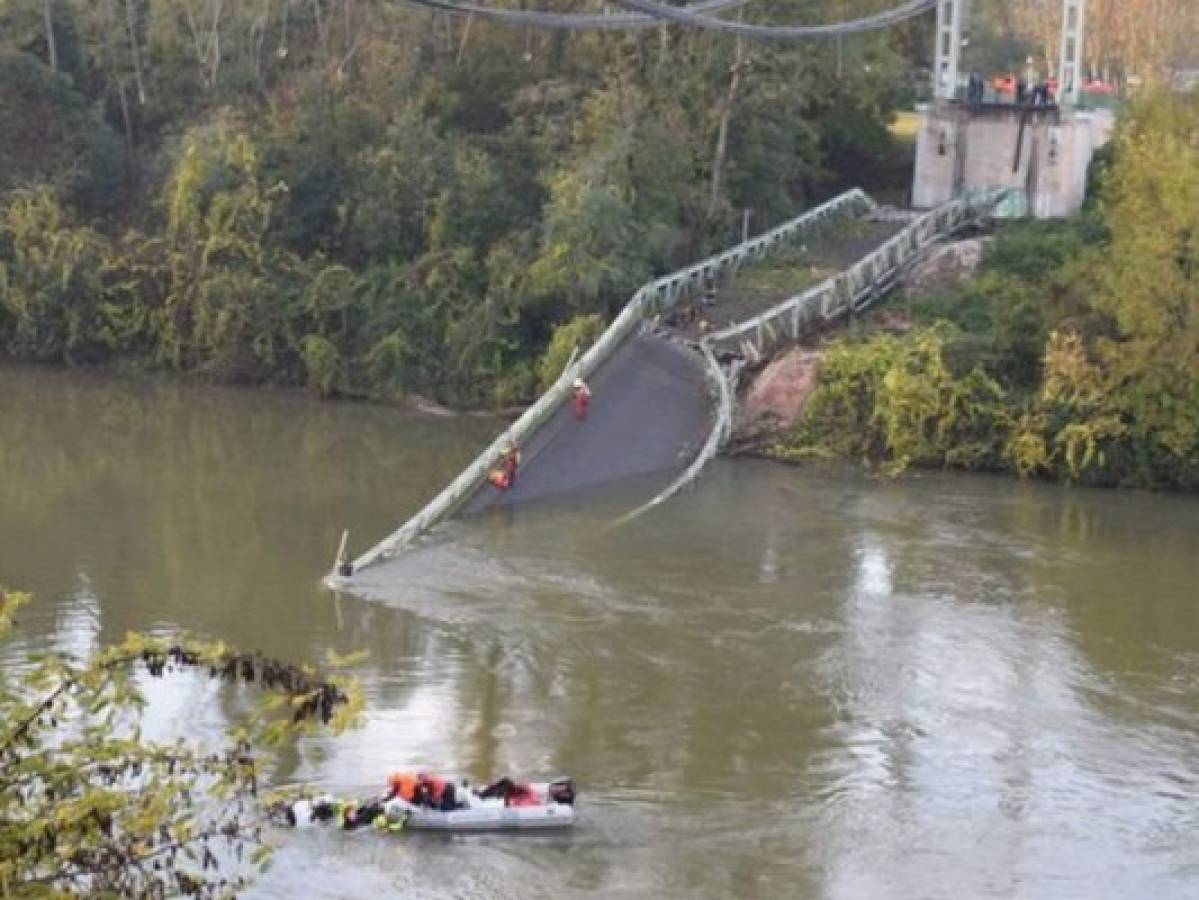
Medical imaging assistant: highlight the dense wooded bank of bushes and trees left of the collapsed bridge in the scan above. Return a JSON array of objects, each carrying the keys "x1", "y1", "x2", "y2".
[{"x1": 0, "y1": 0, "x2": 902, "y2": 404}]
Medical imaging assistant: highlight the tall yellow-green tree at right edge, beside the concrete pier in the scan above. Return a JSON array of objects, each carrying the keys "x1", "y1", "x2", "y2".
[{"x1": 1078, "y1": 92, "x2": 1199, "y2": 484}]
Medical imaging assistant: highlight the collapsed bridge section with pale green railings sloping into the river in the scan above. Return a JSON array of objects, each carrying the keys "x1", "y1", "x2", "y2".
[{"x1": 329, "y1": 188, "x2": 1002, "y2": 586}]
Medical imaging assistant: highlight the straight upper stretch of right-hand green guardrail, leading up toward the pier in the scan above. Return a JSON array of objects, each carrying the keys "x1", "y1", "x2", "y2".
[{"x1": 704, "y1": 188, "x2": 1011, "y2": 357}]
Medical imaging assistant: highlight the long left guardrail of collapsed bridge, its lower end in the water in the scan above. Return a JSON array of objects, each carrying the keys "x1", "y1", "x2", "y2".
[{"x1": 342, "y1": 188, "x2": 876, "y2": 577}]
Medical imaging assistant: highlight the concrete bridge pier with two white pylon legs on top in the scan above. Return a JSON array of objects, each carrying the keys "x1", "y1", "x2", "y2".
[{"x1": 911, "y1": 0, "x2": 1111, "y2": 218}]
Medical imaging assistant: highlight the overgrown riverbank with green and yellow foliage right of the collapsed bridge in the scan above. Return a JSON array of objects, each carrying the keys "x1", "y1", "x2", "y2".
[{"x1": 738, "y1": 93, "x2": 1199, "y2": 491}]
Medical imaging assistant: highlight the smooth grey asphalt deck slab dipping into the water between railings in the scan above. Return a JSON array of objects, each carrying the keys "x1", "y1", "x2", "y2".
[{"x1": 466, "y1": 334, "x2": 712, "y2": 512}]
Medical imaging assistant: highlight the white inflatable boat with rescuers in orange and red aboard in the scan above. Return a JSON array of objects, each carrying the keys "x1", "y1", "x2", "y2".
[{"x1": 285, "y1": 779, "x2": 576, "y2": 832}]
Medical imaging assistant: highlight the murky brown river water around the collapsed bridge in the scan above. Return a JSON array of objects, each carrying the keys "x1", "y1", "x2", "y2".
[{"x1": 0, "y1": 361, "x2": 1199, "y2": 898}]
